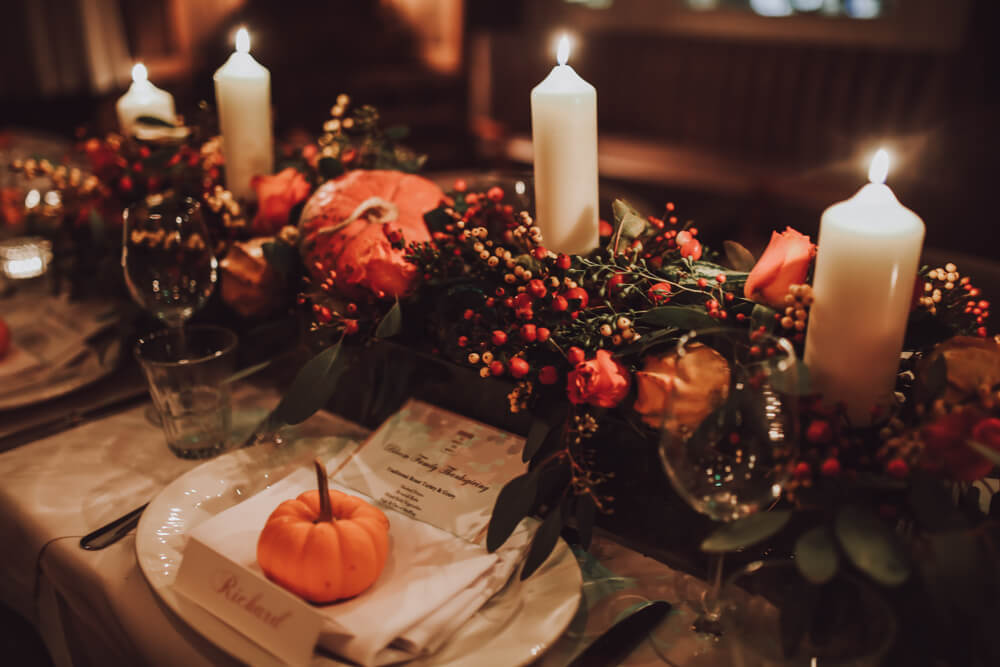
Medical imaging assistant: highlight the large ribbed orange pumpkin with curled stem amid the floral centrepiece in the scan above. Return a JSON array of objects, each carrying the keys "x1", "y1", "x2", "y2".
[{"x1": 299, "y1": 169, "x2": 444, "y2": 298}]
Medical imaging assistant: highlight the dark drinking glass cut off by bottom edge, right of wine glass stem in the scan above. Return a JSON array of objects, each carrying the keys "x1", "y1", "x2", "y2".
[{"x1": 722, "y1": 560, "x2": 896, "y2": 667}]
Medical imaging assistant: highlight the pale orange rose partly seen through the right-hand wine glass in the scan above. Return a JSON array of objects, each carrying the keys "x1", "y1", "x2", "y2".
[{"x1": 632, "y1": 343, "x2": 729, "y2": 433}]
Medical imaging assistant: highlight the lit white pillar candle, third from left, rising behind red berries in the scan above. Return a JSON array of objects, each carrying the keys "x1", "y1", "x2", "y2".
[{"x1": 531, "y1": 36, "x2": 598, "y2": 254}]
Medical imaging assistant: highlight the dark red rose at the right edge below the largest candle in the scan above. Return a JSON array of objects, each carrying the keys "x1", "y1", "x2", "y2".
[{"x1": 920, "y1": 409, "x2": 1000, "y2": 482}]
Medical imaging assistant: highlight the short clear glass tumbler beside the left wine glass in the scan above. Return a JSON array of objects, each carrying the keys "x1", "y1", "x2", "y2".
[{"x1": 135, "y1": 326, "x2": 237, "y2": 459}]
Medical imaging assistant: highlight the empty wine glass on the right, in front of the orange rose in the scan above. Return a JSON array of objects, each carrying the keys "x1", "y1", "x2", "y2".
[{"x1": 659, "y1": 328, "x2": 799, "y2": 656}]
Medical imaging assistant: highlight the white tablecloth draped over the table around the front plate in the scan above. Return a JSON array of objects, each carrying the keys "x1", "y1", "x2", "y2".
[{"x1": 0, "y1": 387, "x2": 720, "y2": 667}]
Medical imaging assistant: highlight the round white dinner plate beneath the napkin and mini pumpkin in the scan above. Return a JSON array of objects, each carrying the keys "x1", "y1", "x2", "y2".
[{"x1": 135, "y1": 418, "x2": 582, "y2": 667}]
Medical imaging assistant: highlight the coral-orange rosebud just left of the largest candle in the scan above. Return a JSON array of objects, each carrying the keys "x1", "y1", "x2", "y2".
[{"x1": 743, "y1": 227, "x2": 816, "y2": 307}]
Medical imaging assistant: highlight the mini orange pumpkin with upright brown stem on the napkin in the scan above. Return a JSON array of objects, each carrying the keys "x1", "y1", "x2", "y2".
[{"x1": 257, "y1": 460, "x2": 389, "y2": 603}]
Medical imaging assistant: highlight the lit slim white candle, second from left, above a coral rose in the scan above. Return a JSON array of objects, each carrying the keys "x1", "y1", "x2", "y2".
[{"x1": 215, "y1": 28, "x2": 274, "y2": 199}]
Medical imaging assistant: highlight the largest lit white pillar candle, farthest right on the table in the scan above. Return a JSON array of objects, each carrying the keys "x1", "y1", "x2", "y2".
[{"x1": 805, "y1": 150, "x2": 924, "y2": 425}]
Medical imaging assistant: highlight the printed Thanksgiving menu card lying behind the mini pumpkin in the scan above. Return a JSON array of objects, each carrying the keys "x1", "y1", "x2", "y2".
[{"x1": 333, "y1": 400, "x2": 526, "y2": 541}]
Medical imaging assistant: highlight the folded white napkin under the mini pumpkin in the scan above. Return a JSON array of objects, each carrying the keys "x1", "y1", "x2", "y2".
[{"x1": 192, "y1": 460, "x2": 533, "y2": 665}]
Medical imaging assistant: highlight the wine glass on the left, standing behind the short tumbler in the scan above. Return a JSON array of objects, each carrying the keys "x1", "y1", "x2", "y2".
[{"x1": 122, "y1": 195, "x2": 218, "y2": 346}]
